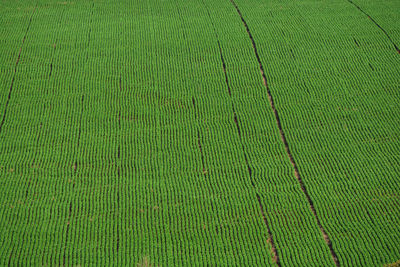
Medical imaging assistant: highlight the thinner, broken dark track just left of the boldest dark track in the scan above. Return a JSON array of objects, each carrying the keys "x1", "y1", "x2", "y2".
[{"x1": 202, "y1": 0, "x2": 281, "y2": 266}]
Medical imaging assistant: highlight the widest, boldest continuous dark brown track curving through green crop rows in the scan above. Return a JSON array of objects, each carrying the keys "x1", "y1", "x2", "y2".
[{"x1": 229, "y1": 0, "x2": 340, "y2": 266}]
